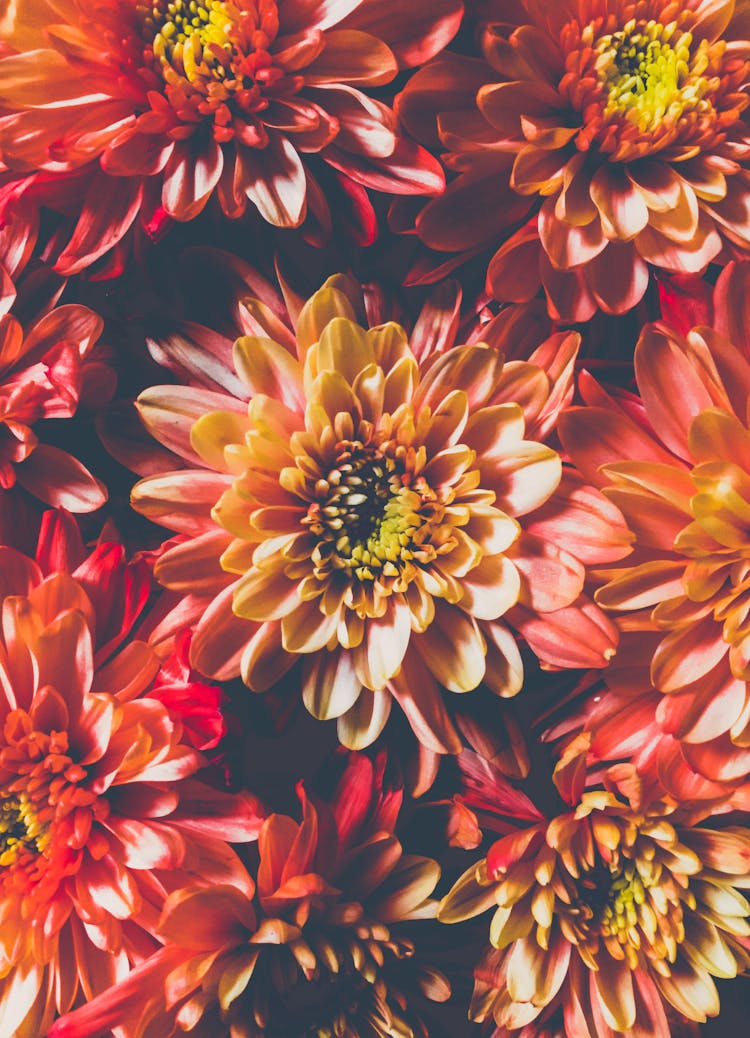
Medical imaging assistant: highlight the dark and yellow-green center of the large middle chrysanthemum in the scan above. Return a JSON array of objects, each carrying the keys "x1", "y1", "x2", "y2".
[{"x1": 303, "y1": 441, "x2": 436, "y2": 581}]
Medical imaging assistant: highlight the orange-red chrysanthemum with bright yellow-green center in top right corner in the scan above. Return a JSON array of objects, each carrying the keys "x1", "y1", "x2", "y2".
[{"x1": 397, "y1": 0, "x2": 750, "y2": 321}]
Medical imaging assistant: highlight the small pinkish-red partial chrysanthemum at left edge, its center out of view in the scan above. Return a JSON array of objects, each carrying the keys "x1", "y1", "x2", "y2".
[{"x1": 0, "y1": 286, "x2": 109, "y2": 512}]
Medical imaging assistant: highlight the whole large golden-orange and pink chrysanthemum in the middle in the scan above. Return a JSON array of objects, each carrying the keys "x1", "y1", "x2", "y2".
[{"x1": 133, "y1": 277, "x2": 630, "y2": 753}]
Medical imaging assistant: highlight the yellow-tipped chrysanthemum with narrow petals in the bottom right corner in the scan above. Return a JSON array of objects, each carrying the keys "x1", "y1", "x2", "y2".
[{"x1": 439, "y1": 768, "x2": 750, "y2": 1038}]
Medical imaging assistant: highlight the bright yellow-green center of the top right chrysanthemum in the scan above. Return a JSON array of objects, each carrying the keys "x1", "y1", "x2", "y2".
[{"x1": 595, "y1": 20, "x2": 710, "y2": 133}]
